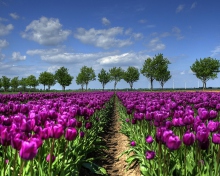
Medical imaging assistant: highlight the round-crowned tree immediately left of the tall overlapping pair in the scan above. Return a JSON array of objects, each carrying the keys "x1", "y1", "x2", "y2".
[{"x1": 123, "y1": 66, "x2": 140, "y2": 90}]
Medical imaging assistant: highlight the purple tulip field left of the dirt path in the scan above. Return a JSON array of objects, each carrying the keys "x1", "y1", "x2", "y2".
[{"x1": 0, "y1": 92, "x2": 114, "y2": 176}]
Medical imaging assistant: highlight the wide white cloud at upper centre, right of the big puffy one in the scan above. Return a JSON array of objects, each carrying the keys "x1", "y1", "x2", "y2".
[{"x1": 74, "y1": 27, "x2": 132, "y2": 49}]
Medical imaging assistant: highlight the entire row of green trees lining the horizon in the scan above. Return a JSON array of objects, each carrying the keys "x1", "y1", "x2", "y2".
[{"x1": 0, "y1": 54, "x2": 220, "y2": 91}]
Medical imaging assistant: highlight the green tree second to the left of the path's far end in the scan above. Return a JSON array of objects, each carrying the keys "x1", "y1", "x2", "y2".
[{"x1": 76, "y1": 66, "x2": 96, "y2": 90}]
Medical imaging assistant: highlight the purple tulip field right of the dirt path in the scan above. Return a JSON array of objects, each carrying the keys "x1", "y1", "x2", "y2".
[{"x1": 117, "y1": 92, "x2": 220, "y2": 176}]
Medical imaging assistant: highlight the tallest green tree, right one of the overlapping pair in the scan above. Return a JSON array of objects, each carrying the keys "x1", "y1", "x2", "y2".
[{"x1": 153, "y1": 54, "x2": 171, "y2": 89}]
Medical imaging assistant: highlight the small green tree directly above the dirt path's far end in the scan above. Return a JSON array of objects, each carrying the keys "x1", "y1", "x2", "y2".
[{"x1": 109, "y1": 67, "x2": 124, "y2": 90}]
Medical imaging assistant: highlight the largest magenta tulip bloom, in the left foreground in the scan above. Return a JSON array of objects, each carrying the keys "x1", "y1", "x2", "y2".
[{"x1": 19, "y1": 141, "x2": 38, "y2": 160}]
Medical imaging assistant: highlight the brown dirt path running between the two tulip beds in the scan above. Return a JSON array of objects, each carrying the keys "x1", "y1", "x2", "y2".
[{"x1": 80, "y1": 97, "x2": 140, "y2": 176}]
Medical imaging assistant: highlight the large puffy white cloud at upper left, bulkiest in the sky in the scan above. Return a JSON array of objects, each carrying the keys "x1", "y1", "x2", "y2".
[{"x1": 21, "y1": 17, "x2": 71, "y2": 45}]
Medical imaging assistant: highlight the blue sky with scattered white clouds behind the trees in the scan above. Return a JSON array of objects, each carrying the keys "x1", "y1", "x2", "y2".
[{"x1": 0, "y1": 0, "x2": 220, "y2": 90}]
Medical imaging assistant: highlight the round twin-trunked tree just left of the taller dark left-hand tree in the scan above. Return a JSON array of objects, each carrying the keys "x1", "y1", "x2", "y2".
[{"x1": 38, "y1": 71, "x2": 56, "y2": 90}]
